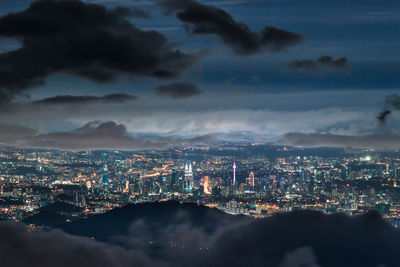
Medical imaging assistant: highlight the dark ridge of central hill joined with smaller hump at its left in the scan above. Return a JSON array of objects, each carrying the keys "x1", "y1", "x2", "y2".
[{"x1": 24, "y1": 201, "x2": 252, "y2": 242}]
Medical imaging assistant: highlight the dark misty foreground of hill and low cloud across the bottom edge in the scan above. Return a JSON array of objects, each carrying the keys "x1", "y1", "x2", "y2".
[{"x1": 0, "y1": 201, "x2": 400, "y2": 267}]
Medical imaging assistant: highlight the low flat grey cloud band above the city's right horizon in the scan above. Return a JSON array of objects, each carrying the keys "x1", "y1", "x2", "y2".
[{"x1": 277, "y1": 133, "x2": 400, "y2": 150}]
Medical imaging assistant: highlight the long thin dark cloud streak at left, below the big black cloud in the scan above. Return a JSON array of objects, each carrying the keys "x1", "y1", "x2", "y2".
[{"x1": 33, "y1": 94, "x2": 137, "y2": 105}]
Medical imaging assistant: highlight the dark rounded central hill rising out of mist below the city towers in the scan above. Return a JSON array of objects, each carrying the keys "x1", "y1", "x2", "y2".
[{"x1": 59, "y1": 201, "x2": 252, "y2": 245}]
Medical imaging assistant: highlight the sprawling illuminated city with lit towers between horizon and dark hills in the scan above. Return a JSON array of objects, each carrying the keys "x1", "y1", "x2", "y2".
[{"x1": 0, "y1": 146, "x2": 400, "y2": 225}]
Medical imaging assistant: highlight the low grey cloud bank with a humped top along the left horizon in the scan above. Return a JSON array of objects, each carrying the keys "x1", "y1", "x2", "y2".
[{"x1": 0, "y1": 121, "x2": 214, "y2": 150}]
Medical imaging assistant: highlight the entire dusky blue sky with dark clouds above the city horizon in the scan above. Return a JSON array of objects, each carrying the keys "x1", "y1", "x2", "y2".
[{"x1": 0, "y1": 0, "x2": 400, "y2": 149}]
